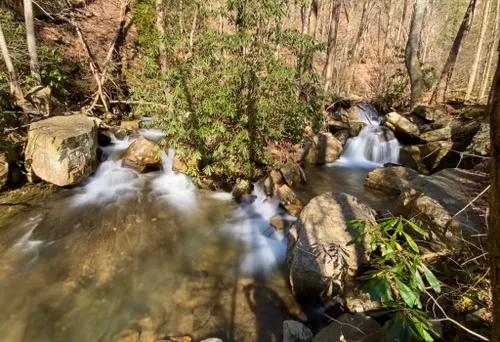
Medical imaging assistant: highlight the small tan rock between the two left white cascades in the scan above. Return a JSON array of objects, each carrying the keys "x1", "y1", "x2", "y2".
[{"x1": 123, "y1": 136, "x2": 161, "y2": 172}]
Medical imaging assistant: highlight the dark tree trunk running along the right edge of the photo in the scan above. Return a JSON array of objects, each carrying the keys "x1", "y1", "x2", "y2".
[{"x1": 488, "y1": 34, "x2": 500, "y2": 341}]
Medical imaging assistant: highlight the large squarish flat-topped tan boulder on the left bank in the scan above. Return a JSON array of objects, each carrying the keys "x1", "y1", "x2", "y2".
[{"x1": 25, "y1": 115, "x2": 97, "y2": 186}]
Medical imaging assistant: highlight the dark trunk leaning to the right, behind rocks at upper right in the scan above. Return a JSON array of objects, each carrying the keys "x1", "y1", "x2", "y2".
[{"x1": 430, "y1": 0, "x2": 476, "y2": 103}]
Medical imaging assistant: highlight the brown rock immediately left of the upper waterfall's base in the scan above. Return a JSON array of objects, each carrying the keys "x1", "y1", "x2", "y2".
[{"x1": 305, "y1": 133, "x2": 343, "y2": 165}]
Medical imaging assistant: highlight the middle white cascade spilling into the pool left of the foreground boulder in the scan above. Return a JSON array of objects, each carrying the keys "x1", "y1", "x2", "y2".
[{"x1": 224, "y1": 185, "x2": 286, "y2": 276}]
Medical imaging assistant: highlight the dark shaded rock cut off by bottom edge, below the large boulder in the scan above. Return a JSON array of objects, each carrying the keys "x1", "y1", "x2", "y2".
[{"x1": 313, "y1": 313, "x2": 386, "y2": 342}]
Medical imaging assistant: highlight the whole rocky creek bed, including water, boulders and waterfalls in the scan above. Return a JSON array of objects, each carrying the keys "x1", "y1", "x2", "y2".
[{"x1": 0, "y1": 104, "x2": 489, "y2": 342}]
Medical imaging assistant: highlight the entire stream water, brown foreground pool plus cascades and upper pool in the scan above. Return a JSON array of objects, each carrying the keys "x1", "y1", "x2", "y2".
[{"x1": 0, "y1": 103, "x2": 399, "y2": 342}]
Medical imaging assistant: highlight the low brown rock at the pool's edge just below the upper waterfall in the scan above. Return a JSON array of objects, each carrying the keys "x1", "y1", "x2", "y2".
[{"x1": 365, "y1": 166, "x2": 418, "y2": 195}]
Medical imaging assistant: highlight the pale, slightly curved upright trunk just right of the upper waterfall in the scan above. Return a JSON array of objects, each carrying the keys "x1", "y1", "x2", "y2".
[{"x1": 405, "y1": 0, "x2": 426, "y2": 110}]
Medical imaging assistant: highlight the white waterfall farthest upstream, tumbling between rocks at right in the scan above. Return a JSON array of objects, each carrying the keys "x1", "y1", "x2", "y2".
[{"x1": 335, "y1": 103, "x2": 401, "y2": 167}]
